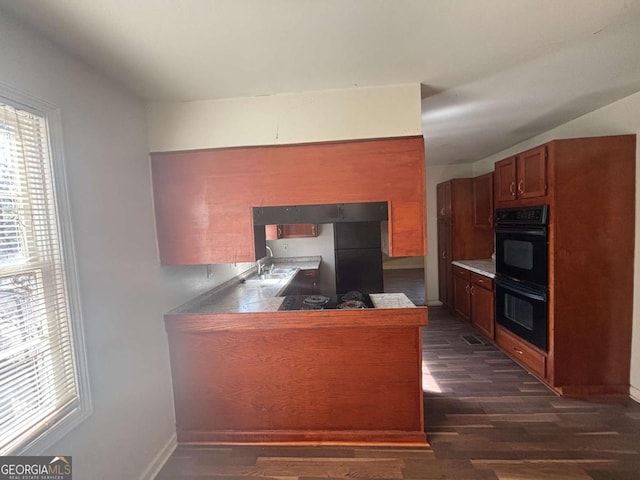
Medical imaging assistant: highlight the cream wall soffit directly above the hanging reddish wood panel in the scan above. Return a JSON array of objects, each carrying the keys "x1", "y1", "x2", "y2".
[{"x1": 147, "y1": 83, "x2": 422, "y2": 152}]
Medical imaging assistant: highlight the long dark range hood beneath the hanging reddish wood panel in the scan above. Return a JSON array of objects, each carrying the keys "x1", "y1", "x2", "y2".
[{"x1": 253, "y1": 202, "x2": 389, "y2": 226}]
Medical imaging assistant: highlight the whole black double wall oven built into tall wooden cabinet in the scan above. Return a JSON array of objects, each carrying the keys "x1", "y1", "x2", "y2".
[{"x1": 495, "y1": 205, "x2": 549, "y2": 351}]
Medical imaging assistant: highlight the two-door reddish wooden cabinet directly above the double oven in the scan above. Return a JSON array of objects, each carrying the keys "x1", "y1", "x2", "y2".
[{"x1": 494, "y1": 145, "x2": 547, "y2": 206}]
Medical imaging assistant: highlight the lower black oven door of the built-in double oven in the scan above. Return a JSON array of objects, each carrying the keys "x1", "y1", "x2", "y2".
[{"x1": 495, "y1": 275, "x2": 548, "y2": 351}]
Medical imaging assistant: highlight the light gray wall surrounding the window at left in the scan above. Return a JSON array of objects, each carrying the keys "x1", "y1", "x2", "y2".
[{"x1": 0, "y1": 14, "x2": 252, "y2": 480}]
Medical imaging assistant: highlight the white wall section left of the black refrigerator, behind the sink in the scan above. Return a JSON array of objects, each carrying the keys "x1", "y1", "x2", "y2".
[{"x1": 267, "y1": 223, "x2": 336, "y2": 295}]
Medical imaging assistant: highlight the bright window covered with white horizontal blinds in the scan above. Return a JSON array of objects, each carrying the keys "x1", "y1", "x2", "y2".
[{"x1": 0, "y1": 97, "x2": 90, "y2": 455}]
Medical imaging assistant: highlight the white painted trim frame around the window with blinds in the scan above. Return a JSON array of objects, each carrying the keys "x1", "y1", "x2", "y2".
[{"x1": 0, "y1": 83, "x2": 93, "y2": 455}]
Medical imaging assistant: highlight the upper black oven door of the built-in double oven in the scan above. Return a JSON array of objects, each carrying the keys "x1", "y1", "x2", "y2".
[{"x1": 496, "y1": 226, "x2": 549, "y2": 287}]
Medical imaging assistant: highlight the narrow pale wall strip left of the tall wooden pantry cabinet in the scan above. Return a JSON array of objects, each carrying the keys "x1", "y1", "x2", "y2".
[{"x1": 424, "y1": 163, "x2": 472, "y2": 305}]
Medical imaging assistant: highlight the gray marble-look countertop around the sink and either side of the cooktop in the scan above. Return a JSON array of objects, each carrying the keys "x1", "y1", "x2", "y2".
[{"x1": 167, "y1": 253, "x2": 415, "y2": 315}]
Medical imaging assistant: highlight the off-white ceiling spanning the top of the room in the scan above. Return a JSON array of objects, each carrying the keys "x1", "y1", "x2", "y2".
[{"x1": 0, "y1": 0, "x2": 640, "y2": 165}]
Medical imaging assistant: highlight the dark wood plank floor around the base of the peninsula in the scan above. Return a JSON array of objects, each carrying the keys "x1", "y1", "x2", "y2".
[{"x1": 157, "y1": 308, "x2": 640, "y2": 480}]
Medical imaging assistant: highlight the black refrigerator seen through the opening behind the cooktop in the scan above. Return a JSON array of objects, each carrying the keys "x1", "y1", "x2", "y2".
[{"x1": 333, "y1": 222, "x2": 384, "y2": 294}]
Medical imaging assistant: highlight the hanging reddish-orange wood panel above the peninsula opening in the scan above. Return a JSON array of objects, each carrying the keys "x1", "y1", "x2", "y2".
[{"x1": 151, "y1": 137, "x2": 426, "y2": 264}]
